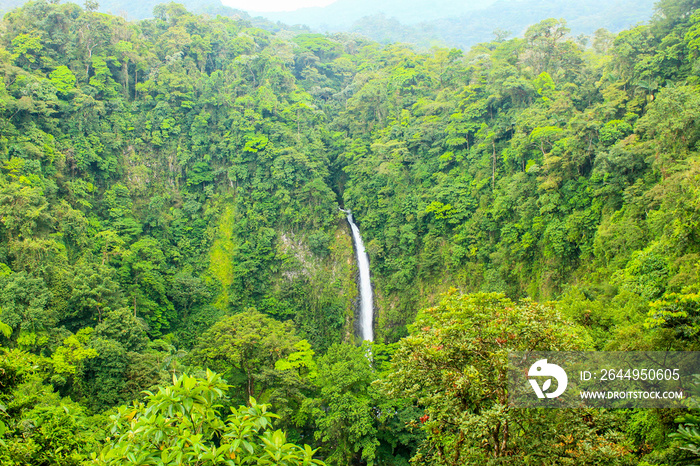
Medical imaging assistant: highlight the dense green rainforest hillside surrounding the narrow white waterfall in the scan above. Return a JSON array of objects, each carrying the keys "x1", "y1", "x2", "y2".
[{"x1": 0, "y1": 0, "x2": 700, "y2": 466}]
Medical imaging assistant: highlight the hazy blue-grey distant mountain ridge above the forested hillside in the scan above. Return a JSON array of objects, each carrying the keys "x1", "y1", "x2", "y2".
[{"x1": 0, "y1": 0, "x2": 655, "y2": 49}]
